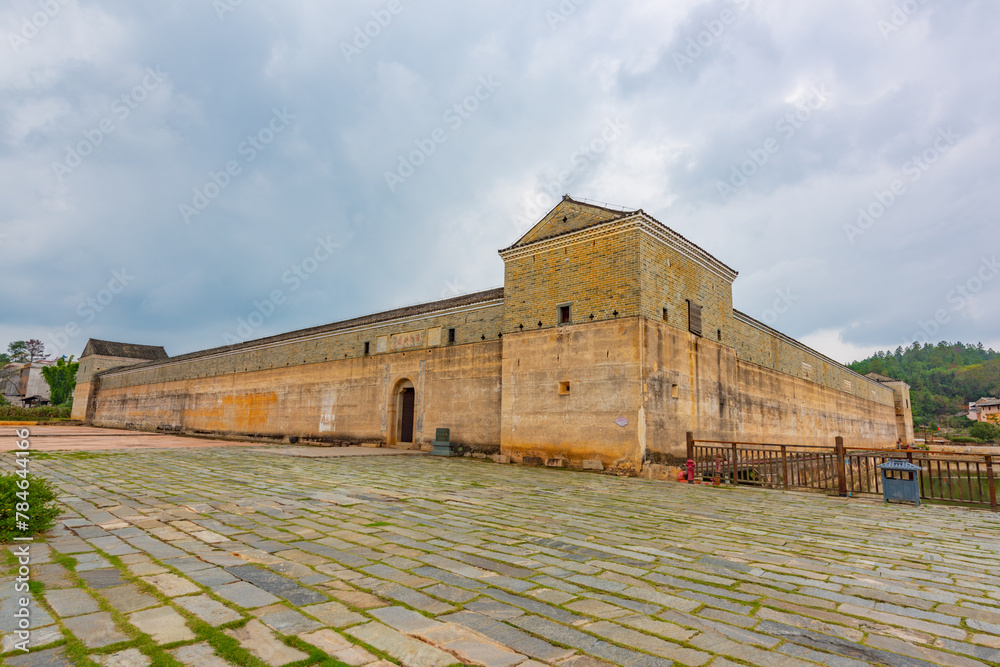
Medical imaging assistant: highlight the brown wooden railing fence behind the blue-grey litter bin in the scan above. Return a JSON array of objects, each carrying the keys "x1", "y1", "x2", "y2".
[{"x1": 687, "y1": 433, "x2": 997, "y2": 511}]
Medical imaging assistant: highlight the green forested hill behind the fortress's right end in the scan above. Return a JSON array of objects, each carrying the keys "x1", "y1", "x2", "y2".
[{"x1": 849, "y1": 343, "x2": 1000, "y2": 425}]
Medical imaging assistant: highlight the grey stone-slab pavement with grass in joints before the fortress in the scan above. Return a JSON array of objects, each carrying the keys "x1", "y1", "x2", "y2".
[{"x1": 0, "y1": 448, "x2": 1000, "y2": 667}]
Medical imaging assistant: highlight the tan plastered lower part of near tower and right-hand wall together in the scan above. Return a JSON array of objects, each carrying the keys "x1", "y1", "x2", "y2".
[{"x1": 501, "y1": 318, "x2": 897, "y2": 472}]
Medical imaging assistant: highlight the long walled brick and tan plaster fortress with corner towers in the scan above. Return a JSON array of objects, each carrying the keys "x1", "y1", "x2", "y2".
[{"x1": 74, "y1": 197, "x2": 913, "y2": 473}]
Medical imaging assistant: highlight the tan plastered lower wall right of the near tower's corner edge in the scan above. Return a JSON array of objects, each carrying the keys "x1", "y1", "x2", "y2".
[{"x1": 644, "y1": 321, "x2": 897, "y2": 458}]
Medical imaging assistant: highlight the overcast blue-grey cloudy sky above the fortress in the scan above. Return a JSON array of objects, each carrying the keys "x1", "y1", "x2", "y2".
[{"x1": 0, "y1": 0, "x2": 1000, "y2": 362}]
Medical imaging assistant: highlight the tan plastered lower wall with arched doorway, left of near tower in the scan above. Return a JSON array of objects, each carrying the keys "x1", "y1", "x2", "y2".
[{"x1": 93, "y1": 341, "x2": 501, "y2": 451}]
